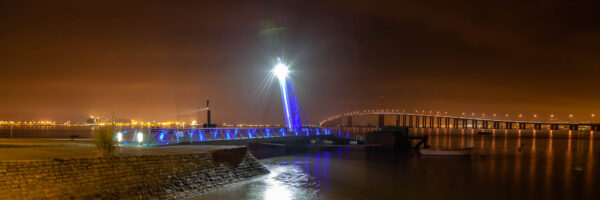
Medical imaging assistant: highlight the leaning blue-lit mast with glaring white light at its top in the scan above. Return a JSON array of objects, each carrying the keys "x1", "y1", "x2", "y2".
[{"x1": 271, "y1": 58, "x2": 302, "y2": 131}]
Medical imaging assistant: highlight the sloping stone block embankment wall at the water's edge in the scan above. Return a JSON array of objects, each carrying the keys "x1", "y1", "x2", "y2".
[{"x1": 0, "y1": 147, "x2": 268, "y2": 199}]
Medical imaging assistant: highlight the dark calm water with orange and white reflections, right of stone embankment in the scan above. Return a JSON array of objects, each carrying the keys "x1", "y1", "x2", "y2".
[{"x1": 193, "y1": 130, "x2": 600, "y2": 200}]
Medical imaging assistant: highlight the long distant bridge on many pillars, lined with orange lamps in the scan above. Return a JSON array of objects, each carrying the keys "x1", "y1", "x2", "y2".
[{"x1": 319, "y1": 110, "x2": 600, "y2": 131}]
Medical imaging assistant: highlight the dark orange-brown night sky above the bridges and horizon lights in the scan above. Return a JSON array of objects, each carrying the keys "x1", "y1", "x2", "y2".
[{"x1": 0, "y1": 0, "x2": 600, "y2": 123}]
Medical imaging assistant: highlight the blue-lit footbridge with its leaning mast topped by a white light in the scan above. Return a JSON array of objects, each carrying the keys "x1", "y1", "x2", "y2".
[{"x1": 116, "y1": 58, "x2": 350, "y2": 146}]
